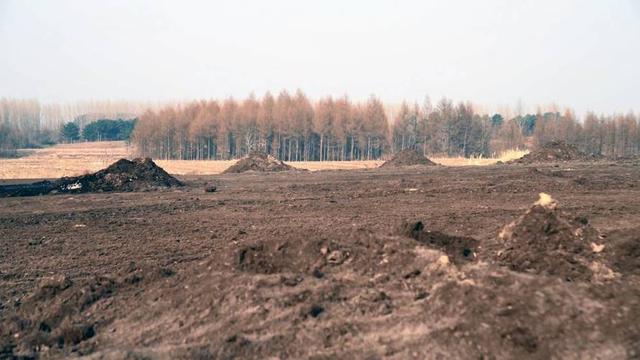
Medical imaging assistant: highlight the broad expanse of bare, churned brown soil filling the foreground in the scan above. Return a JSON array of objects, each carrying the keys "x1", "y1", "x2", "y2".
[{"x1": 0, "y1": 161, "x2": 640, "y2": 359}]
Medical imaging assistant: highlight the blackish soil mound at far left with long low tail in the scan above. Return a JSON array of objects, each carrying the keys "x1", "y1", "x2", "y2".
[{"x1": 0, "y1": 158, "x2": 183, "y2": 197}]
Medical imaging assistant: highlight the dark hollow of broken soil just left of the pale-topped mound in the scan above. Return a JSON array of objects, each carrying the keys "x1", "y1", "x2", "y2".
[{"x1": 398, "y1": 221, "x2": 478, "y2": 265}]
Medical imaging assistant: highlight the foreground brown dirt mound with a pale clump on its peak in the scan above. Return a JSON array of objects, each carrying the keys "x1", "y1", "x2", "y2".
[{"x1": 496, "y1": 193, "x2": 612, "y2": 281}]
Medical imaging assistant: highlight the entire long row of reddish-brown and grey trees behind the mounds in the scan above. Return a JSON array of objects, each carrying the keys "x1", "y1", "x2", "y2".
[{"x1": 132, "y1": 91, "x2": 640, "y2": 161}]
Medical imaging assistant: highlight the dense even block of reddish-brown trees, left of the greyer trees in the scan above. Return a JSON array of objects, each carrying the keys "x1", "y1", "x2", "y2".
[{"x1": 132, "y1": 91, "x2": 389, "y2": 161}]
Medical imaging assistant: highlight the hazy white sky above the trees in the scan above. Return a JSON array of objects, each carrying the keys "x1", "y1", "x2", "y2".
[{"x1": 0, "y1": 0, "x2": 640, "y2": 112}]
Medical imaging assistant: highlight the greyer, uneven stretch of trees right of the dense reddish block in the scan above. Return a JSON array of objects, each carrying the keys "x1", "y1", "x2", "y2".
[{"x1": 392, "y1": 99, "x2": 640, "y2": 157}]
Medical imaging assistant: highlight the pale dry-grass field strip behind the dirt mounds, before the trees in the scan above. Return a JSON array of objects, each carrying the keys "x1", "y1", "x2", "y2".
[{"x1": 0, "y1": 141, "x2": 526, "y2": 179}]
